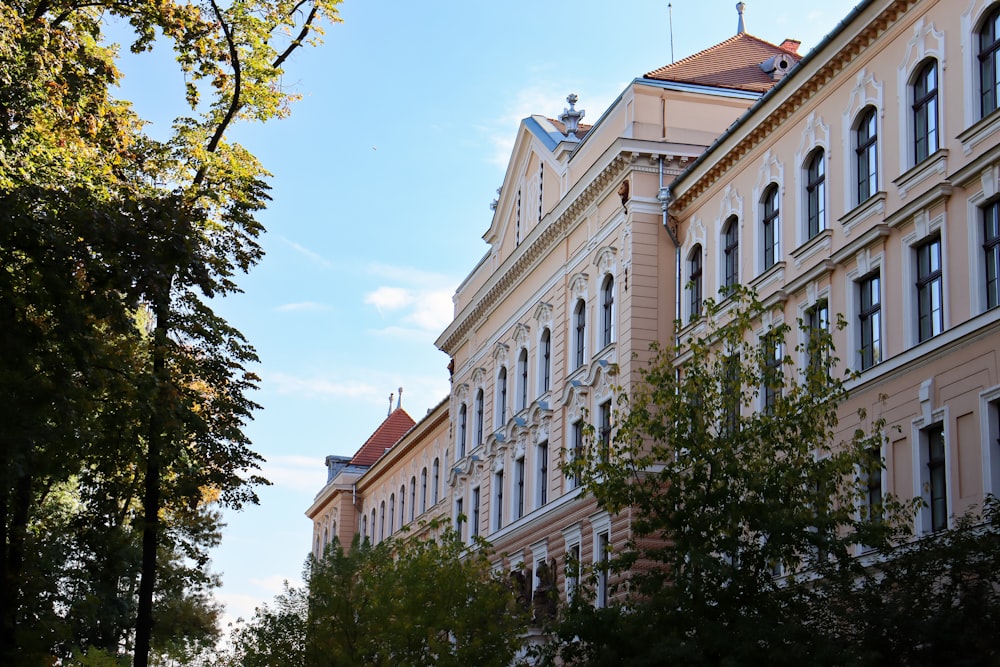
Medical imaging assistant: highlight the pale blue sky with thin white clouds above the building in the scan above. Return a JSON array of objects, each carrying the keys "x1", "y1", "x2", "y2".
[{"x1": 109, "y1": 0, "x2": 856, "y2": 618}]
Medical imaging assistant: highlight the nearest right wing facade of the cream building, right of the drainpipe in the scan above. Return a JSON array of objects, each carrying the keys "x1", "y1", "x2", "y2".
[{"x1": 669, "y1": 0, "x2": 1000, "y2": 534}]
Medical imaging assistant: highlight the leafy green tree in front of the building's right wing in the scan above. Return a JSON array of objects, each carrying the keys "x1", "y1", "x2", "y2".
[{"x1": 550, "y1": 288, "x2": 906, "y2": 665}]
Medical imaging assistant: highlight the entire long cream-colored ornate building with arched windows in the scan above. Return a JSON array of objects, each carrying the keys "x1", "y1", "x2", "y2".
[{"x1": 307, "y1": 0, "x2": 1000, "y2": 604}]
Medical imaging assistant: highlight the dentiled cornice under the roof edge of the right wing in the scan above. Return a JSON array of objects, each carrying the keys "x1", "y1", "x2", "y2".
[{"x1": 673, "y1": 0, "x2": 919, "y2": 215}]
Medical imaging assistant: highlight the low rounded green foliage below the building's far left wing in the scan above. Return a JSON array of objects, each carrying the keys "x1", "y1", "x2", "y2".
[{"x1": 228, "y1": 531, "x2": 527, "y2": 667}]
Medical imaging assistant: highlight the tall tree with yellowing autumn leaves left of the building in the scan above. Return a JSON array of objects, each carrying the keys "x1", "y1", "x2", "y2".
[{"x1": 0, "y1": 0, "x2": 338, "y2": 665}]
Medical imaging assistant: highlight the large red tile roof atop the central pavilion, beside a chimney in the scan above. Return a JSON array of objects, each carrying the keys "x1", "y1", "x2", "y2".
[{"x1": 645, "y1": 32, "x2": 802, "y2": 93}]
